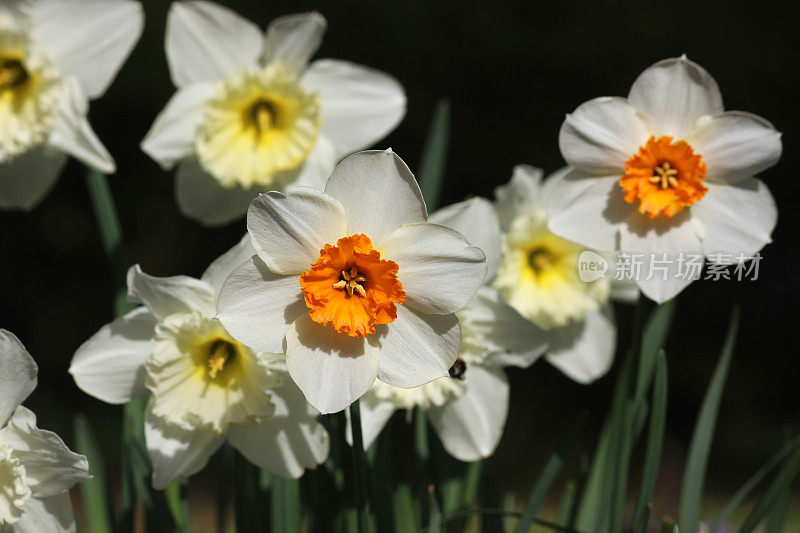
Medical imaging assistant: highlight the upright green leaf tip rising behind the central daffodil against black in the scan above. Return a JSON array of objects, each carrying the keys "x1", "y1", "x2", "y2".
[{"x1": 417, "y1": 99, "x2": 450, "y2": 212}]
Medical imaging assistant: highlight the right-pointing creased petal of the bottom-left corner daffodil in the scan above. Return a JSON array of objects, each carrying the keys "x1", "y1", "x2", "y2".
[{"x1": 2, "y1": 406, "x2": 91, "y2": 498}]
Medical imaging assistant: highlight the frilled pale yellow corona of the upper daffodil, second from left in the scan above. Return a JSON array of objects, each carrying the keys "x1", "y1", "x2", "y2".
[{"x1": 195, "y1": 64, "x2": 321, "y2": 187}]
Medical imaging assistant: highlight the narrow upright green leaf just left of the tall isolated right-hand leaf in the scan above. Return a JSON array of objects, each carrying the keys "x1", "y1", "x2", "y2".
[{"x1": 631, "y1": 350, "x2": 668, "y2": 533}]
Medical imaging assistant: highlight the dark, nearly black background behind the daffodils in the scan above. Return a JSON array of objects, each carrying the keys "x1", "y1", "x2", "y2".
[{"x1": 0, "y1": 0, "x2": 800, "y2": 517}]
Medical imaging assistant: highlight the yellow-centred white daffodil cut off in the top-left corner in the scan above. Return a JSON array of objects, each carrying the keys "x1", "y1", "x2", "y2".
[{"x1": 0, "y1": 0, "x2": 144, "y2": 210}]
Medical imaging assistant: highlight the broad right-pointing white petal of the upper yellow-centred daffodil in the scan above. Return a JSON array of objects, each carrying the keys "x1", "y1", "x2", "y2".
[{"x1": 300, "y1": 59, "x2": 406, "y2": 158}]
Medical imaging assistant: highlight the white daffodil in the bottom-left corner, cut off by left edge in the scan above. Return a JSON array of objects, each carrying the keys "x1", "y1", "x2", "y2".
[{"x1": 0, "y1": 329, "x2": 91, "y2": 533}]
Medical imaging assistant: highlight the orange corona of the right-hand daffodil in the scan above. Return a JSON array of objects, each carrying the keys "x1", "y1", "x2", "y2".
[{"x1": 620, "y1": 136, "x2": 706, "y2": 218}]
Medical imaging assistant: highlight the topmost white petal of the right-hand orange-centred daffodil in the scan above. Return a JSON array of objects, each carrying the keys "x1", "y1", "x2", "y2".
[{"x1": 628, "y1": 56, "x2": 723, "y2": 138}]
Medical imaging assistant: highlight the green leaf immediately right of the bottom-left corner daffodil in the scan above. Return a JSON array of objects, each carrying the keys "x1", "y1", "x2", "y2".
[{"x1": 75, "y1": 414, "x2": 113, "y2": 533}]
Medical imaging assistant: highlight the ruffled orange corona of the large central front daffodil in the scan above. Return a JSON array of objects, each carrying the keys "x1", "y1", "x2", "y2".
[{"x1": 300, "y1": 235, "x2": 406, "y2": 337}]
